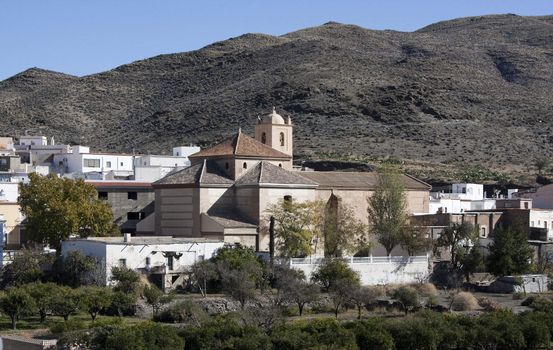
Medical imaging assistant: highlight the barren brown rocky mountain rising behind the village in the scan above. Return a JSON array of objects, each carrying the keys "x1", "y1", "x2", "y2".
[{"x1": 0, "y1": 15, "x2": 553, "y2": 176}]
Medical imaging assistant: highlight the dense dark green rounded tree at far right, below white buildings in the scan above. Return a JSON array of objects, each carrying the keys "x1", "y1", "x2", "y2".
[{"x1": 487, "y1": 225, "x2": 532, "y2": 276}]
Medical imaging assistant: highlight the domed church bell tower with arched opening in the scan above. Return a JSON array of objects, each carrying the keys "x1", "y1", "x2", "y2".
[{"x1": 255, "y1": 107, "x2": 293, "y2": 156}]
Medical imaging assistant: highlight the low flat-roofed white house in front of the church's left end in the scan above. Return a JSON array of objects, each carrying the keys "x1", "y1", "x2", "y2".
[{"x1": 61, "y1": 234, "x2": 224, "y2": 290}]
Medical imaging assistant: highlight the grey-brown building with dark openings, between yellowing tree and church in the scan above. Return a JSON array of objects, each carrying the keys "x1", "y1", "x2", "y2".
[{"x1": 86, "y1": 180, "x2": 155, "y2": 233}]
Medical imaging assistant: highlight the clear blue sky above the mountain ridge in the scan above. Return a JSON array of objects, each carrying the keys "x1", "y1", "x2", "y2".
[{"x1": 0, "y1": 0, "x2": 553, "y2": 80}]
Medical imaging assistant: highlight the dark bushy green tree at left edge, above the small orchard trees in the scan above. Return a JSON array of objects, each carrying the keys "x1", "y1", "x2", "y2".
[{"x1": 1, "y1": 249, "x2": 48, "y2": 289}]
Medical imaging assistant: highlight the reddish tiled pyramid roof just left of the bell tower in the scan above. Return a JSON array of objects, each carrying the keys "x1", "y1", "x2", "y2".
[{"x1": 188, "y1": 131, "x2": 291, "y2": 159}]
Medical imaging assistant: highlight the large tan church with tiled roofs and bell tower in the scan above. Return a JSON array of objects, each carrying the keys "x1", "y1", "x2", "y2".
[{"x1": 148, "y1": 109, "x2": 430, "y2": 254}]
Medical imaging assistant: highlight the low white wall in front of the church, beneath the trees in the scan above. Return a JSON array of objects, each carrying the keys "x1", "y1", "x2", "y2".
[{"x1": 289, "y1": 256, "x2": 431, "y2": 286}]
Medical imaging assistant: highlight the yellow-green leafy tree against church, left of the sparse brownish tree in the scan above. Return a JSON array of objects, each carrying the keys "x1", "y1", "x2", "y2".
[{"x1": 266, "y1": 200, "x2": 324, "y2": 258}]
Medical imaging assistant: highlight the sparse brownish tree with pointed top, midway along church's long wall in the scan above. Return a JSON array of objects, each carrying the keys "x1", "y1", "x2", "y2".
[{"x1": 323, "y1": 194, "x2": 369, "y2": 258}]
